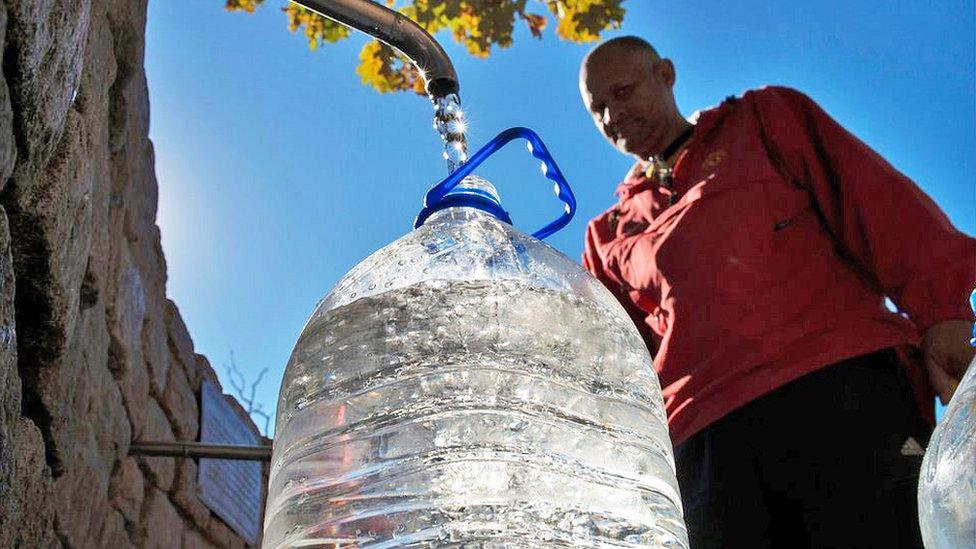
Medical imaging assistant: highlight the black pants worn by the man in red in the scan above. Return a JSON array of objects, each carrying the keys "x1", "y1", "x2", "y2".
[{"x1": 675, "y1": 351, "x2": 932, "y2": 549}]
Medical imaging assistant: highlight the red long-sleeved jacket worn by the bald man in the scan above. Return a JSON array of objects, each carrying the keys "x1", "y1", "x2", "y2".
[{"x1": 583, "y1": 87, "x2": 976, "y2": 444}]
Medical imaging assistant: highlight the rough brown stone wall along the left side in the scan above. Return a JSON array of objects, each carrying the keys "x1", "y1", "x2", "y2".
[{"x1": 0, "y1": 0, "x2": 266, "y2": 548}]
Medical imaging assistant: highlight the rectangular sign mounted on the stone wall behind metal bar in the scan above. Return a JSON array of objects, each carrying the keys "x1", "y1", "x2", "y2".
[{"x1": 197, "y1": 379, "x2": 262, "y2": 545}]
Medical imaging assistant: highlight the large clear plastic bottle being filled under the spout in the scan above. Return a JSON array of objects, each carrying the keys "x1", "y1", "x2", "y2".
[{"x1": 264, "y1": 130, "x2": 688, "y2": 548}]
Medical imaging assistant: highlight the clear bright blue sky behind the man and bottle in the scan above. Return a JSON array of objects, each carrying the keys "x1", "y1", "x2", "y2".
[{"x1": 146, "y1": 0, "x2": 976, "y2": 430}]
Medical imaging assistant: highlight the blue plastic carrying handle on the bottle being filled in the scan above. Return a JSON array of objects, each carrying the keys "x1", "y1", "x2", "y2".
[{"x1": 415, "y1": 127, "x2": 576, "y2": 240}]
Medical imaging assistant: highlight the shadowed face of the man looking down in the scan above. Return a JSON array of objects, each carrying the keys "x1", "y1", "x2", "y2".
[{"x1": 580, "y1": 48, "x2": 680, "y2": 159}]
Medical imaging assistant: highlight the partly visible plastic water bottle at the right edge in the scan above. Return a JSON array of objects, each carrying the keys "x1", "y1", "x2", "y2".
[{"x1": 918, "y1": 292, "x2": 976, "y2": 549}]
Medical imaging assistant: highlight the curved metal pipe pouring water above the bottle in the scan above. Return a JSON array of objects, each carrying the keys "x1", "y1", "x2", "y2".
[{"x1": 291, "y1": 0, "x2": 460, "y2": 99}]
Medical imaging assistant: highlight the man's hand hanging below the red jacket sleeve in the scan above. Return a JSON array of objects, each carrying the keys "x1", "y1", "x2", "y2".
[{"x1": 922, "y1": 320, "x2": 976, "y2": 404}]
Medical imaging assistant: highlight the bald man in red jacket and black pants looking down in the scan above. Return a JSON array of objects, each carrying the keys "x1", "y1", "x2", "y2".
[{"x1": 580, "y1": 37, "x2": 976, "y2": 549}]
